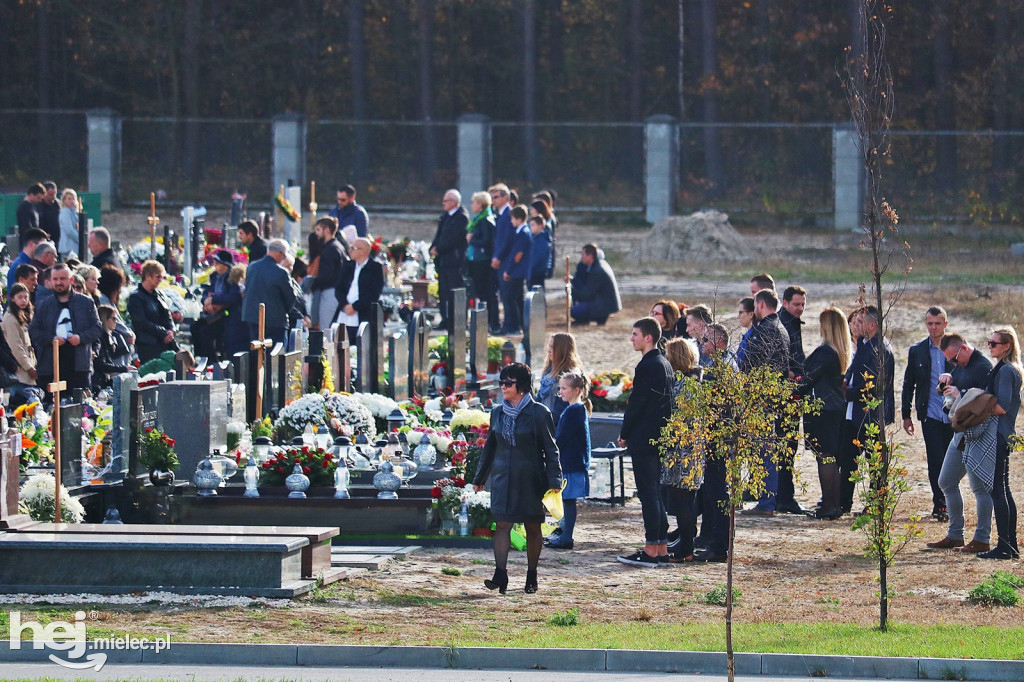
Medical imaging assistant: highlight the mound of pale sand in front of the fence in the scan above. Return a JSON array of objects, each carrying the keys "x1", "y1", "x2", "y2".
[{"x1": 639, "y1": 210, "x2": 754, "y2": 263}]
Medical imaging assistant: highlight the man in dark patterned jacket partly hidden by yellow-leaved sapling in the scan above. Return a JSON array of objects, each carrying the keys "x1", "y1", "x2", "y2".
[{"x1": 739, "y1": 289, "x2": 790, "y2": 516}]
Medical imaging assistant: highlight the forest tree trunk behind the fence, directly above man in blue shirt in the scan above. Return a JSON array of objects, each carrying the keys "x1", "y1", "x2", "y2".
[{"x1": 932, "y1": 0, "x2": 956, "y2": 193}]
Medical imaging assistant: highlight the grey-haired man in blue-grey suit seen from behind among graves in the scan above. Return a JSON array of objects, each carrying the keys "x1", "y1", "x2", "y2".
[{"x1": 242, "y1": 238, "x2": 296, "y2": 343}]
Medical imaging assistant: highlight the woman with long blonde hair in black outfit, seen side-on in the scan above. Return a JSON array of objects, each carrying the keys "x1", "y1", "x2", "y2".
[{"x1": 797, "y1": 307, "x2": 850, "y2": 521}]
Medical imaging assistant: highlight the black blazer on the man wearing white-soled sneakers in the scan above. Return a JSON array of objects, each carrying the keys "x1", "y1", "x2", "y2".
[{"x1": 620, "y1": 348, "x2": 676, "y2": 457}]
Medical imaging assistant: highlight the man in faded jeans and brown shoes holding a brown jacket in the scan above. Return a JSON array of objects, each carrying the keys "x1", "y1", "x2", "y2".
[{"x1": 927, "y1": 334, "x2": 992, "y2": 554}]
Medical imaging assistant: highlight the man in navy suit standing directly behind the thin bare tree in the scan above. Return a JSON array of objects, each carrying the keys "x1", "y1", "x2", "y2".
[{"x1": 839, "y1": 305, "x2": 896, "y2": 513}]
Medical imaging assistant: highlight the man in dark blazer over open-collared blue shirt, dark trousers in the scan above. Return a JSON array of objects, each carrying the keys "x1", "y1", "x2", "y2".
[{"x1": 902, "y1": 306, "x2": 953, "y2": 521}]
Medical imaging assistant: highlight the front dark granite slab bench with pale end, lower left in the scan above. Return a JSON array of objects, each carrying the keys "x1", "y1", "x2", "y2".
[{"x1": 0, "y1": 531, "x2": 315, "y2": 598}]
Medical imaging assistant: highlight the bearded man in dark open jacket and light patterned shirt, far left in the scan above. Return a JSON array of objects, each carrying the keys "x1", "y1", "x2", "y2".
[{"x1": 29, "y1": 263, "x2": 102, "y2": 390}]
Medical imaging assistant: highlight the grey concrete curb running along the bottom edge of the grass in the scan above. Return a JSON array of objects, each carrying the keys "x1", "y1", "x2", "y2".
[{"x1": 0, "y1": 641, "x2": 1024, "y2": 682}]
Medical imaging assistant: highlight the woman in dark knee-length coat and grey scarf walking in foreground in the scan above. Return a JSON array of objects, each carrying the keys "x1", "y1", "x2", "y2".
[{"x1": 473, "y1": 363, "x2": 562, "y2": 594}]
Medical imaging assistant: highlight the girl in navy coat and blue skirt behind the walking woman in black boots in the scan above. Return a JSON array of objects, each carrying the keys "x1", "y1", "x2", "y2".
[{"x1": 547, "y1": 370, "x2": 590, "y2": 549}]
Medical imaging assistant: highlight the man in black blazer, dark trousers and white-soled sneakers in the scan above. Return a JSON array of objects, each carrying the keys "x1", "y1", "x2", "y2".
[{"x1": 618, "y1": 317, "x2": 675, "y2": 568}]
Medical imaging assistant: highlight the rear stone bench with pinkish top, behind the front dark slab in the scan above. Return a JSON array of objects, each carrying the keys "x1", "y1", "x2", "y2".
[{"x1": 22, "y1": 523, "x2": 345, "y2": 584}]
